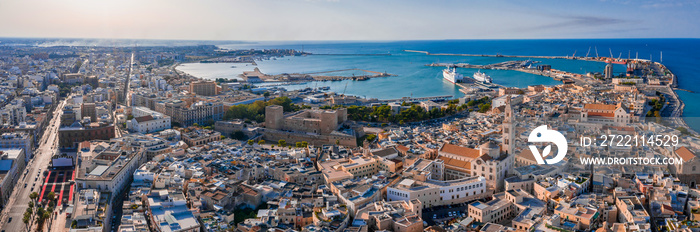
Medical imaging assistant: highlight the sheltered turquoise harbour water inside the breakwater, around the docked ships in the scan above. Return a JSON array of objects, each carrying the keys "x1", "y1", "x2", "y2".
[{"x1": 178, "y1": 48, "x2": 623, "y2": 99}]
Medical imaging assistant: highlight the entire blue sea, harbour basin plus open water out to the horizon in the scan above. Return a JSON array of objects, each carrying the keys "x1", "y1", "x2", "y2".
[{"x1": 178, "y1": 39, "x2": 700, "y2": 130}]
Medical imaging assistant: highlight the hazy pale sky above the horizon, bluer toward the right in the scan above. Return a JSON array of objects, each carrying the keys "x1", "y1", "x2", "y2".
[{"x1": 0, "y1": 0, "x2": 700, "y2": 41}]
